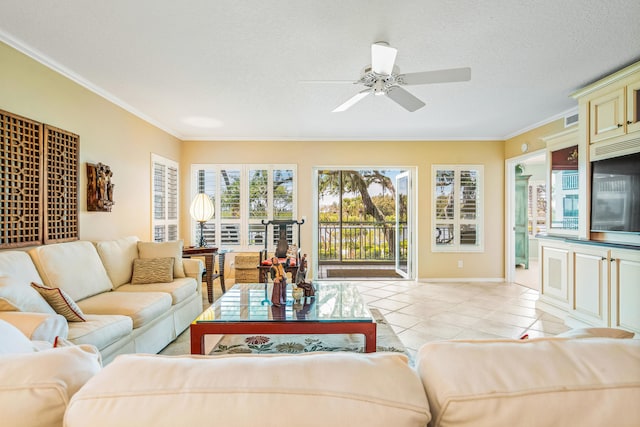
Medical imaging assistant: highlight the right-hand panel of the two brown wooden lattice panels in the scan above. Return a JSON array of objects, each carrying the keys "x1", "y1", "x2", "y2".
[{"x1": 44, "y1": 125, "x2": 80, "y2": 243}]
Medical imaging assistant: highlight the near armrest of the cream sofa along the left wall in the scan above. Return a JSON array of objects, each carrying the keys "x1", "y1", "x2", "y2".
[{"x1": 0, "y1": 311, "x2": 69, "y2": 343}]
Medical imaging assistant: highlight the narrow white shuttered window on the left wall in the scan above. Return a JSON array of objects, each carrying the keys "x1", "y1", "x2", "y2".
[{"x1": 151, "y1": 154, "x2": 178, "y2": 242}]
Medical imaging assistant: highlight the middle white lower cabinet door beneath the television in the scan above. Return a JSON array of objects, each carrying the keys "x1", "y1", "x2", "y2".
[{"x1": 572, "y1": 248, "x2": 609, "y2": 327}]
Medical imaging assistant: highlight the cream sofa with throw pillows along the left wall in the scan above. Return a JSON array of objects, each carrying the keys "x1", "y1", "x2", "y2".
[{"x1": 0, "y1": 237, "x2": 203, "y2": 364}]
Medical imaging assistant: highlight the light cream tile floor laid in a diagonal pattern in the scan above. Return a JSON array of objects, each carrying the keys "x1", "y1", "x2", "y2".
[{"x1": 204, "y1": 280, "x2": 569, "y2": 356}]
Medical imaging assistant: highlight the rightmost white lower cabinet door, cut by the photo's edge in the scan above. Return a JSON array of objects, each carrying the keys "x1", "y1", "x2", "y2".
[{"x1": 611, "y1": 250, "x2": 640, "y2": 334}]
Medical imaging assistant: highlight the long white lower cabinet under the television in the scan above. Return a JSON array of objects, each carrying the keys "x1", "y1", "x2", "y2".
[{"x1": 537, "y1": 239, "x2": 640, "y2": 334}]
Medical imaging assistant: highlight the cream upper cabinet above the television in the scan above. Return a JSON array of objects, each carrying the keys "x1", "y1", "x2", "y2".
[{"x1": 589, "y1": 77, "x2": 640, "y2": 144}]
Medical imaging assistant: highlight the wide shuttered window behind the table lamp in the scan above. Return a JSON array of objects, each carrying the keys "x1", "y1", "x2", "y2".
[{"x1": 191, "y1": 165, "x2": 297, "y2": 250}]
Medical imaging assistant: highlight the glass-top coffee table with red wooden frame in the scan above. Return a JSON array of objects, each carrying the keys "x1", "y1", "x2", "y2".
[{"x1": 190, "y1": 283, "x2": 376, "y2": 354}]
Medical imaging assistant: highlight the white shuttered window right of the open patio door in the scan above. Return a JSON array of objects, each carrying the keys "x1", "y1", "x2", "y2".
[{"x1": 432, "y1": 165, "x2": 484, "y2": 252}]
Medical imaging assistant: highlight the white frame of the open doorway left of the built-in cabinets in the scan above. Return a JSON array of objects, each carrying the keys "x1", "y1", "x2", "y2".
[{"x1": 504, "y1": 148, "x2": 549, "y2": 283}]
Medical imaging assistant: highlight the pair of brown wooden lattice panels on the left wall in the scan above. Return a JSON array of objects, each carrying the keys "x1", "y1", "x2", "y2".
[{"x1": 0, "y1": 110, "x2": 80, "y2": 249}]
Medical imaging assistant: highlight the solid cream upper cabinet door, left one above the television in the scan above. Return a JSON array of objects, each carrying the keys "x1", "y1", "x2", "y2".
[{"x1": 589, "y1": 88, "x2": 626, "y2": 144}]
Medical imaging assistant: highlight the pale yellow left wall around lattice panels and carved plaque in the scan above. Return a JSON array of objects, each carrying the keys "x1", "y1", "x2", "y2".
[{"x1": 0, "y1": 43, "x2": 180, "y2": 240}]
